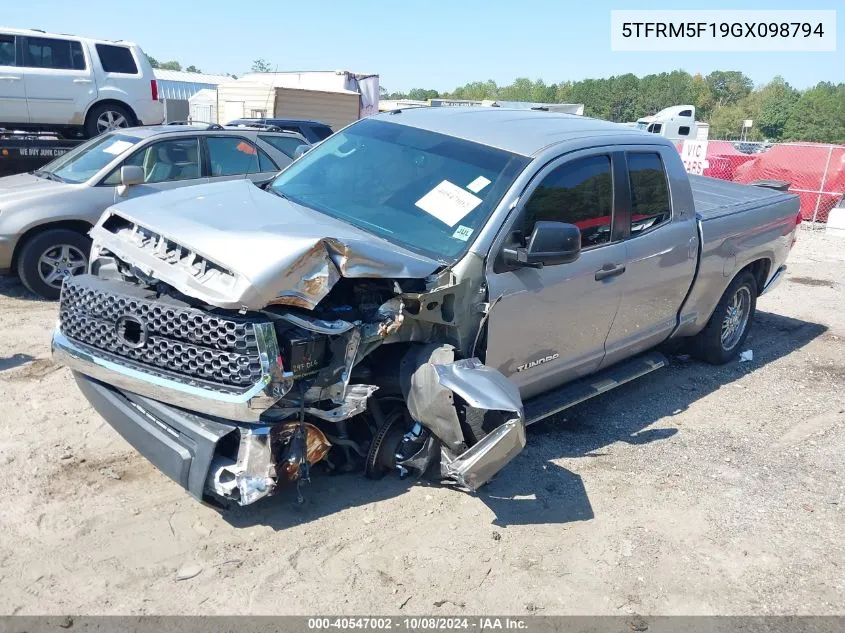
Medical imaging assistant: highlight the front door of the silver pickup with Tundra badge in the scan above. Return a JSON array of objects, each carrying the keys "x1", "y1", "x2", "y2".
[{"x1": 485, "y1": 149, "x2": 627, "y2": 398}]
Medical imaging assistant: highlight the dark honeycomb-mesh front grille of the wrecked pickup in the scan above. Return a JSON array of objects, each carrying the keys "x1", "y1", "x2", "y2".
[{"x1": 59, "y1": 275, "x2": 262, "y2": 388}]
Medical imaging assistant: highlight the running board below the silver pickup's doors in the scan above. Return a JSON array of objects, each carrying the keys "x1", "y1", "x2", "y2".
[{"x1": 524, "y1": 352, "x2": 669, "y2": 425}]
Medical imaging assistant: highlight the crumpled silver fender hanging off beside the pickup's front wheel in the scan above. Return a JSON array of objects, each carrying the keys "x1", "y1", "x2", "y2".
[{"x1": 400, "y1": 344, "x2": 525, "y2": 490}]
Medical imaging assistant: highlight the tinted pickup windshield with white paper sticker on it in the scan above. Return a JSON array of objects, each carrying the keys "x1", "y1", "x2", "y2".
[{"x1": 269, "y1": 119, "x2": 529, "y2": 261}]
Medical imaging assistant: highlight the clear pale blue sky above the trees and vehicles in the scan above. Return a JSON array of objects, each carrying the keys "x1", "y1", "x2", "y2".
[{"x1": 0, "y1": 0, "x2": 845, "y2": 92}]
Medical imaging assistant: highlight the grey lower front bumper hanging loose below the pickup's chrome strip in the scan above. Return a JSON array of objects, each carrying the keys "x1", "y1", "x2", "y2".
[{"x1": 74, "y1": 372, "x2": 239, "y2": 500}]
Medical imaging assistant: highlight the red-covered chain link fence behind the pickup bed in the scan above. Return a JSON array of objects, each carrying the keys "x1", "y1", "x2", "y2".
[{"x1": 678, "y1": 139, "x2": 845, "y2": 227}]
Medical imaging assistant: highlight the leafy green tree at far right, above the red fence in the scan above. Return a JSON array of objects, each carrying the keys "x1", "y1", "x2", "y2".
[{"x1": 783, "y1": 81, "x2": 845, "y2": 143}]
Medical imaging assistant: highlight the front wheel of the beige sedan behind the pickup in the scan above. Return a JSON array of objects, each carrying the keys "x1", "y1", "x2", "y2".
[{"x1": 18, "y1": 229, "x2": 91, "y2": 300}]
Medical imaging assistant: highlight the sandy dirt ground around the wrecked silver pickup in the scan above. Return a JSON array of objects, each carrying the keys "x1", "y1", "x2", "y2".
[{"x1": 0, "y1": 226, "x2": 845, "y2": 615}]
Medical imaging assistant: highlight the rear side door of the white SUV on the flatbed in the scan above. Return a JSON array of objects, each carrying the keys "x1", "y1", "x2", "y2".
[{"x1": 21, "y1": 36, "x2": 92, "y2": 125}]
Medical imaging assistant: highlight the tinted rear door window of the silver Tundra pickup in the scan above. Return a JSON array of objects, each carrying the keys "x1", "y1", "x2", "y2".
[{"x1": 627, "y1": 154, "x2": 672, "y2": 237}]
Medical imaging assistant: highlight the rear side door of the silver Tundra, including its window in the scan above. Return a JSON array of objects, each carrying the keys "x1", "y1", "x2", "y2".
[{"x1": 603, "y1": 145, "x2": 698, "y2": 365}]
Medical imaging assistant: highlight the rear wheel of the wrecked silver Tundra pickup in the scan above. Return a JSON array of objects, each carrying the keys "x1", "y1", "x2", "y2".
[{"x1": 690, "y1": 270, "x2": 757, "y2": 365}]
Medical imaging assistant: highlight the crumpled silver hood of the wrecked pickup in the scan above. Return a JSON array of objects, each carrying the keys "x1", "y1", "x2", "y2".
[{"x1": 91, "y1": 180, "x2": 441, "y2": 309}]
